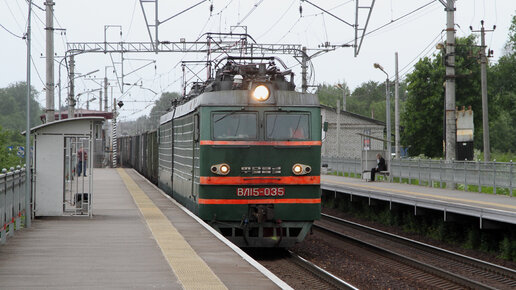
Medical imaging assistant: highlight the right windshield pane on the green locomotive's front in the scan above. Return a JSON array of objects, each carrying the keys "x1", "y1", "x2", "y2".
[{"x1": 265, "y1": 113, "x2": 310, "y2": 140}]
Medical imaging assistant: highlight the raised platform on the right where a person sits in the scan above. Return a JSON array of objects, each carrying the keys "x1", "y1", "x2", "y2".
[{"x1": 321, "y1": 175, "x2": 516, "y2": 228}]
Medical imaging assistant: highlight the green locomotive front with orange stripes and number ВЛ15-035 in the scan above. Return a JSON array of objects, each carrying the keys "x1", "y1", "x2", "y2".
[{"x1": 197, "y1": 59, "x2": 321, "y2": 247}]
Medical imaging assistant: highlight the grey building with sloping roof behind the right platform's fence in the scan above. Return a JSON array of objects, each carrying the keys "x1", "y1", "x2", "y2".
[{"x1": 321, "y1": 105, "x2": 385, "y2": 158}]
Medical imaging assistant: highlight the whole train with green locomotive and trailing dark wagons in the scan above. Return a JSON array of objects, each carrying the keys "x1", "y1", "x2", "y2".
[{"x1": 118, "y1": 57, "x2": 321, "y2": 247}]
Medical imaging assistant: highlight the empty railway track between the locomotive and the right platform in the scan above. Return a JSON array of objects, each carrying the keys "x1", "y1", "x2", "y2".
[{"x1": 314, "y1": 214, "x2": 516, "y2": 289}]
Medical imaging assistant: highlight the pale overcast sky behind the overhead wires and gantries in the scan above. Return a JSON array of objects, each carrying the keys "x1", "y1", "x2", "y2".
[{"x1": 0, "y1": 0, "x2": 516, "y2": 120}]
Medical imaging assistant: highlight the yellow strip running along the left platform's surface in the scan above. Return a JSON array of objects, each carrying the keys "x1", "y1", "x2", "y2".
[{"x1": 117, "y1": 168, "x2": 227, "y2": 289}]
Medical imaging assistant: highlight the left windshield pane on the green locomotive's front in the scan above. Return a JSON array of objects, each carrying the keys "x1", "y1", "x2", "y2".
[{"x1": 212, "y1": 111, "x2": 258, "y2": 140}]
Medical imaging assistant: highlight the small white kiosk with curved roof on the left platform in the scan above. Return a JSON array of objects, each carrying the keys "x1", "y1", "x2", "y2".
[{"x1": 27, "y1": 117, "x2": 104, "y2": 217}]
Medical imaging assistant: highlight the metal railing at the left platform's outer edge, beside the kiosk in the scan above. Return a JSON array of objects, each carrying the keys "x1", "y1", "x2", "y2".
[{"x1": 0, "y1": 166, "x2": 25, "y2": 244}]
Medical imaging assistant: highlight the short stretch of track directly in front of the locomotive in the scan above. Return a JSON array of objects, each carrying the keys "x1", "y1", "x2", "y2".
[{"x1": 248, "y1": 249, "x2": 356, "y2": 289}]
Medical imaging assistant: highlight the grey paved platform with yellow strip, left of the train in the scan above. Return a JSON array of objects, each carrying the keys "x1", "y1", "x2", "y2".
[{"x1": 0, "y1": 169, "x2": 290, "y2": 289}]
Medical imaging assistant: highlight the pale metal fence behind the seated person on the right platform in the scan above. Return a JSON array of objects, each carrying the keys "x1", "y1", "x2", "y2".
[{"x1": 322, "y1": 157, "x2": 516, "y2": 196}]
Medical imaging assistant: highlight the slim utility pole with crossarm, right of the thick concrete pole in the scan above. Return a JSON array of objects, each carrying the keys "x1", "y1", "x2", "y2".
[{"x1": 469, "y1": 20, "x2": 496, "y2": 162}]
